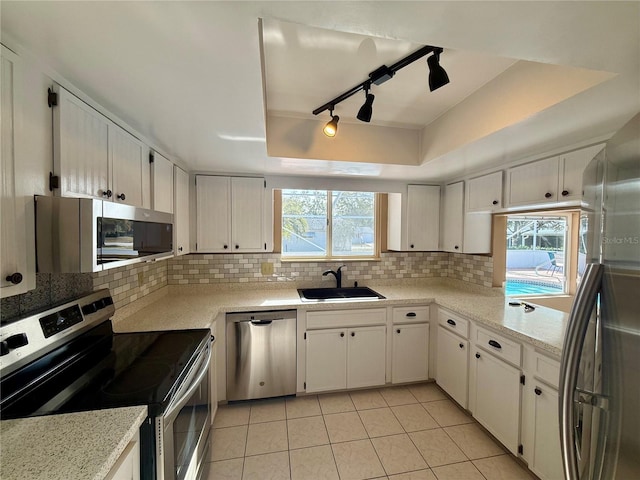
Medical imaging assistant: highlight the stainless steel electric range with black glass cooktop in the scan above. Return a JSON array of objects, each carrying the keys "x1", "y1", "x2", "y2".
[{"x1": 0, "y1": 290, "x2": 212, "y2": 480}]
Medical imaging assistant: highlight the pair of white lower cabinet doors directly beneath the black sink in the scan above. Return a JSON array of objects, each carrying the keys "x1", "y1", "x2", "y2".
[{"x1": 306, "y1": 325, "x2": 386, "y2": 393}]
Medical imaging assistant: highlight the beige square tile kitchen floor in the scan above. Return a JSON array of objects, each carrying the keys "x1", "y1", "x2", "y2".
[{"x1": 209, "y1": 383, "x2": 535, "y2": 480}]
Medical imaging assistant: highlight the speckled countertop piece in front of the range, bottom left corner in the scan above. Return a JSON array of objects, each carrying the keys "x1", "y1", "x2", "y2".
[{"x1": 0, "y1": 406, "x2": 147, "y2": 480}]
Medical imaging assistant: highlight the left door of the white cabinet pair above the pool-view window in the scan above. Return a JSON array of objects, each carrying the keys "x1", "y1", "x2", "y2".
[{"x1": 507, "y1": 157, "x2": 558, "y2": 207}]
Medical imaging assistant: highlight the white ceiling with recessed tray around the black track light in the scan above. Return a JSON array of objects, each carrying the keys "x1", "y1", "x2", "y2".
[{"x1": 0, "y1": 0, "x2": 640, "y2": 181}]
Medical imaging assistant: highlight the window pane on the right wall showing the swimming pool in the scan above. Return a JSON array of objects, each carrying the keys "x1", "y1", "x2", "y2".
[{"x1": 505, "y1": 216, "x2": 567, "y2": 296}]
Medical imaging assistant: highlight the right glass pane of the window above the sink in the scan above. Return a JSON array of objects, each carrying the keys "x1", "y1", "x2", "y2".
[{"x1": 331, "y1": 192, "x2": 375, "y2": 257}]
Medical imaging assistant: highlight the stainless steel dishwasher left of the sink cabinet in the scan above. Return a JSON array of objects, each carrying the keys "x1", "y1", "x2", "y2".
[{"x1": 226, "y1": 310, "x2": 297, "y2": 401}]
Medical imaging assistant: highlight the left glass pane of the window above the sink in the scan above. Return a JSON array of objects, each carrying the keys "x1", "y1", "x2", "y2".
[{"x1": 282, "y1": 190, "x2": 327, "y2": 257}]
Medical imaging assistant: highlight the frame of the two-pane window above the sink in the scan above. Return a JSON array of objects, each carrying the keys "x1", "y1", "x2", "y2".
[{"x1": 273, "y1": 188, "x2": 386, "y2": 263}]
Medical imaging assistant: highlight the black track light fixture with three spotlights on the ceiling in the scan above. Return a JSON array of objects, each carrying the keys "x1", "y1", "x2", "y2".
[{"x1": 313, "y1": 45, "x2": 449, "y2": 133}]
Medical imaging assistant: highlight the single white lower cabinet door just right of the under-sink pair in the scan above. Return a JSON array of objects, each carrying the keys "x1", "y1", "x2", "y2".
[{"x1": 391, "y1": 323, "x2": 429, "y2": 383}]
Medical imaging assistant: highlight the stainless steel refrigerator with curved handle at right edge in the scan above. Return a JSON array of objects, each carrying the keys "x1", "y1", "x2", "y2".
[{"x1": 559, "y1": 114, "x2": 640, "y2": 480}]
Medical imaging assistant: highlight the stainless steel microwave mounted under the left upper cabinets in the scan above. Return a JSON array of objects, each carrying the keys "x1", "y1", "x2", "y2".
[{"x1": 35, "y1": 195, "x2": 173, "y2": 273}]
